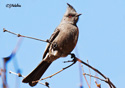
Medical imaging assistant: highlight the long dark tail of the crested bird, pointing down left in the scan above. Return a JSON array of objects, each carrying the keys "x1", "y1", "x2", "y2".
[{"x1": 22, "y1": 61, "x2": 51, "y2": 86}]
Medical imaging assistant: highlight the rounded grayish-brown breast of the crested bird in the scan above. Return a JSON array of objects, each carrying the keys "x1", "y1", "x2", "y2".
[{"x1": 54, "y1": 26, "x2": 79, "y2": 57}]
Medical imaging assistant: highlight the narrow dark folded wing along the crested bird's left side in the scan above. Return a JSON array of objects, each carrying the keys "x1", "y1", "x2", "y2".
[{"x1": 43, "y1": 28, "x2": 60, "y2": 59}]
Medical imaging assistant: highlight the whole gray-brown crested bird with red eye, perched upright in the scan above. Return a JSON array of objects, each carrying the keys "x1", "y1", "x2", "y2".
[{"x1": 22, "y1": 3, "x2": 81, "y2": 86}]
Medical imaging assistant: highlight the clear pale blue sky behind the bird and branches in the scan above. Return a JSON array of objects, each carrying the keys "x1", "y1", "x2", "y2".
[{"x1": 0, "y1": 0, "x2": 125, "y2": 88}]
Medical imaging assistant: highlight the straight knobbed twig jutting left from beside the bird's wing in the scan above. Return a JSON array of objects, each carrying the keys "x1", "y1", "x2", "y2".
[{"x1": 3, "y1": 28, "x2": 50, "y2": 43}]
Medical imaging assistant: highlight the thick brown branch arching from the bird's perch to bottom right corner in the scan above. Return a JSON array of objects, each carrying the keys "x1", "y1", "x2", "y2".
[{"x1": 76, "y1": 57, "x2": 116, "y2": 88}]
